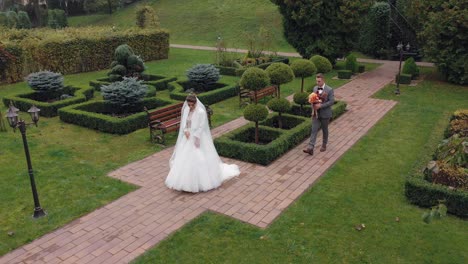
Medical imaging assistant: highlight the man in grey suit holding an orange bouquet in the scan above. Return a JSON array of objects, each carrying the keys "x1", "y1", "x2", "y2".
[{"x1": 303, "y1": 73, "x2": 335, "y2": 155}]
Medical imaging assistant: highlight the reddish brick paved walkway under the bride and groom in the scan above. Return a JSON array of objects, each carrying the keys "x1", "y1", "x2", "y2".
[{"x1": 0, "y1": 57, "x2": 398, "y2": 264}]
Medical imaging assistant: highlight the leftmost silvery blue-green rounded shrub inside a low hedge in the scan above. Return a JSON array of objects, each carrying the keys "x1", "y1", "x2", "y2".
[{"x1": 26, "y1": 71, "x2": 64, "y2": 92}]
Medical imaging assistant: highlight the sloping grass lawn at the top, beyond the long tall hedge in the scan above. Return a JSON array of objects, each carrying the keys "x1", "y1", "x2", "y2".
[{"x1": 69, "y1": 0, "x2": 295, "y2": 52}]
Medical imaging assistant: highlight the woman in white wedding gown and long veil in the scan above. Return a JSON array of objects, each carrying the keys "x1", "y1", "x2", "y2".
[{"x1": 166, "y1": 94, "x2": 240, "y2": 193}]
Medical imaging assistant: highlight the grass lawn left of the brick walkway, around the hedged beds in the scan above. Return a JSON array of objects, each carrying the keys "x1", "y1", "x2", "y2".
[{"x1": 0, "y1": 49, "x2": 362, "y2": 255}]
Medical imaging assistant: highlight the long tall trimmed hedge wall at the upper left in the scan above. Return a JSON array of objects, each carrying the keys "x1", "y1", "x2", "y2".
[{"x1": 0, "y1": 27, "x2": 169, "y2": 82}]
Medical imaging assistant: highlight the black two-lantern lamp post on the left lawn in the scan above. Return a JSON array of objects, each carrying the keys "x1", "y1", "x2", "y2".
[{"x1": 6, "y1": 104, "x2": 46, "y2": 218}]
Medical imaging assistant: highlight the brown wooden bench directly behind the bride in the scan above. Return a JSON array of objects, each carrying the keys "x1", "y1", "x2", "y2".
[{"x1": 145, "y1": 103, "x2": 213, "y2": 144}]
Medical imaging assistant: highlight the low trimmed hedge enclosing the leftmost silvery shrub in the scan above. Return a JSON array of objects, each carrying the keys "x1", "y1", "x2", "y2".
[{"x1": 3, "y1": 86, "x2": 94, "y2": 117}]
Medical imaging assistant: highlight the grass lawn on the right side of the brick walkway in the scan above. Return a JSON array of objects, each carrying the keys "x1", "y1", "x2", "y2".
[{"x1": 135, "y1": 69, "x2": 468, "y2": 263}]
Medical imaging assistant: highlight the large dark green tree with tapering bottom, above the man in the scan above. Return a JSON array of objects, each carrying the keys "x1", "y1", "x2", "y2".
[{"x1": 272, "y1": 0, "x2": 371, "y2": 62}]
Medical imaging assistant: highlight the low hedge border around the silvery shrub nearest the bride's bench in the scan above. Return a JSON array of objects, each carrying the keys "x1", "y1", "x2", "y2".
[{"x1": 59, "y1": 97, "x2": 174, "y2": 134}]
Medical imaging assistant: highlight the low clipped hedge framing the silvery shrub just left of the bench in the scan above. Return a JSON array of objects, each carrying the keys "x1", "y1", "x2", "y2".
[{"x1": 58, "y1": 97, "x2": 175, "y2": 135}]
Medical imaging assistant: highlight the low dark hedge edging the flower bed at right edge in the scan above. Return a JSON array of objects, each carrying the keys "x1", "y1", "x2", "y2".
[{"x1": 405, "y1": 174, "x2": 468, "y2": 217}]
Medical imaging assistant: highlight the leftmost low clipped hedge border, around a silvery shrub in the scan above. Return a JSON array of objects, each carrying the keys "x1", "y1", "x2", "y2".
[{"x1": 3, "y1": 86, "x2": 94, "y2": 117}]
